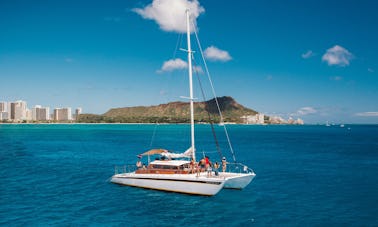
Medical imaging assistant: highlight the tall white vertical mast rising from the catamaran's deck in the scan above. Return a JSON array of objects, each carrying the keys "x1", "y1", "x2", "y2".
[{"x1": 186, "y1": 9, "x2": 196, "y2": 161}]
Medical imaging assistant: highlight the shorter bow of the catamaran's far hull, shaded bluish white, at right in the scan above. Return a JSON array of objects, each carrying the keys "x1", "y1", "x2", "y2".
[{"x1": 220, "y1": 173, "x2": 256, "y2": 189}]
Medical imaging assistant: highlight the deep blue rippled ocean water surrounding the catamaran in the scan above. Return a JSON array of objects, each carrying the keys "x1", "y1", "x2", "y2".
[{"x1": 0, "y1": 124, "x2": 378, "y2": 226}]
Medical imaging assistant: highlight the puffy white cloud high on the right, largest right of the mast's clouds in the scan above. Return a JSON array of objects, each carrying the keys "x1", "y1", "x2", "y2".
[{"x1": 322, "y1": 45, "x2": 353, "y2": 66}]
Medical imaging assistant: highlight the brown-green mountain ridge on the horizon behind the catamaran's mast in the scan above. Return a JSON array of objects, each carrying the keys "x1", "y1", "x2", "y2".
[{"x1": 80, "y1": 96, "x2": 257, "y2": 123}]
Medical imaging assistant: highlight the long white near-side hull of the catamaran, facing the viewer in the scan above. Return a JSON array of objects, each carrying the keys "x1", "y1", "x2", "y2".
[{"x1": 110, "y1": 173, "x2": 225, "y2": 196}]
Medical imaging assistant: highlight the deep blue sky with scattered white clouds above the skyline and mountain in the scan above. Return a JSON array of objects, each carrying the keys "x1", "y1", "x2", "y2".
[{"x1": 0, "y1": 0, "x2": 378, "y2": 123}]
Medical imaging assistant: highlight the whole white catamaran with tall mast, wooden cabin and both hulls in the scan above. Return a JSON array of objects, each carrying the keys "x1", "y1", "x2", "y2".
[{"x1": 111, "y1": 10, "x2": 256, "y2": 196}]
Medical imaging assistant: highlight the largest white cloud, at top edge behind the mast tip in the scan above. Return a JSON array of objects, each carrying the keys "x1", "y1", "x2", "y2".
[{"x1": 133, "y1": 0, "x2": 205, "y2": 33}]
